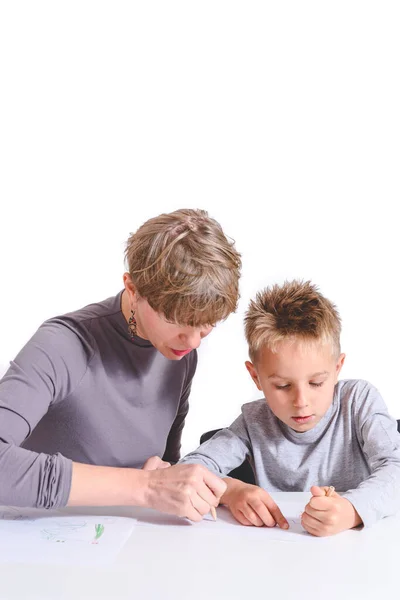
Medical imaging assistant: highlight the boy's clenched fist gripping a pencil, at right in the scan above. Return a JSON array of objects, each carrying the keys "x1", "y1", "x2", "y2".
[{"x1": 301, "y1": 485, "x2": 362, "y2": 537}]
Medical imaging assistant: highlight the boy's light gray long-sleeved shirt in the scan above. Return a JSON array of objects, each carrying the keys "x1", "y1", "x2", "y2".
[{"x1": 181, "y1": 380, "x2": 400, "y2": 525}]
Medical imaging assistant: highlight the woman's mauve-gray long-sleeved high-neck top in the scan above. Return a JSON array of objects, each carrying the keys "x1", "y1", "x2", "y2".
[{"x1": 0, "y1": 292, "x2": 197, "y2": 508}]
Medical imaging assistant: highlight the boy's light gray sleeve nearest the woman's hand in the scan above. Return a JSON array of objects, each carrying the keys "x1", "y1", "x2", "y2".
[{"x1": 179, "y1": 414, "x2": 251, "y2": 477}]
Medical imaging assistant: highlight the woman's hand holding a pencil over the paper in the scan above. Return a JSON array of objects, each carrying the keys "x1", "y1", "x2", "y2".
[{"x1": 144, "y1": 459, "x2": 226, "y2": 521}]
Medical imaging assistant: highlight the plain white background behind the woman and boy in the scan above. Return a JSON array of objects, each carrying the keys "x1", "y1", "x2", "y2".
[{"x1": 0, "y1": 0, "x2": 400, "y2": 458}]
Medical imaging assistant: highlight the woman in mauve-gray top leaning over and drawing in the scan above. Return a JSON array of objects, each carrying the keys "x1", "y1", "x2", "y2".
[{"x1": 0, "y1": 210, "x2": 241, "y2": 521}]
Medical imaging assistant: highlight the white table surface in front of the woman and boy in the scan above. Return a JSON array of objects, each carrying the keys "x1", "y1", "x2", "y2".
[{"x1": 0, "y1": 494, "x2": 400, "y2": 600}]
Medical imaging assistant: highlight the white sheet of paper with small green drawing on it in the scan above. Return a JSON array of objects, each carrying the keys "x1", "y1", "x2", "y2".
[{"x1": 0, "y1": 507, "x2": 136, "y2": 565}]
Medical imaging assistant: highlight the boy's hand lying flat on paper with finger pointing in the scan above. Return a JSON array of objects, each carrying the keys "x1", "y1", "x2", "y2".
[{"x1": 221, "y1": 478, "x2": 289, "y2": 529}]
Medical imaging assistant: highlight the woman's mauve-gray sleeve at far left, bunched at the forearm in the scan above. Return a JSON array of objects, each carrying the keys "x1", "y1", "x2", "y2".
[{"x1": 0, "y1": 322, "x2": 90, "y2": 508}]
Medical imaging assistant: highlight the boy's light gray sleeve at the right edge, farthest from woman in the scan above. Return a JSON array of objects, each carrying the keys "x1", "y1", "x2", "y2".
[{"x1": 343, "y1": 384, "x2": 400, "y2": 527}]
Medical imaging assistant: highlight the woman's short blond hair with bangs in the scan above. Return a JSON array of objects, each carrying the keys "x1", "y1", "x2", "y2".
[{"x1": 125, "y1": 209, "x2": 241, "y2": 327}]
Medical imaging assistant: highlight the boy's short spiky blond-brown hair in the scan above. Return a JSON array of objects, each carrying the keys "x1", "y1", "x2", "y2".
[{"x1": 245, "y1": 280, "x2": 341, "y2": 362}]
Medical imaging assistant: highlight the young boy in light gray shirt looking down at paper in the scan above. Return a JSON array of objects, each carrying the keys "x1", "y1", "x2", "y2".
[{"x1": 181, "y1": 281, "x2": 400, "y2": 536}]
